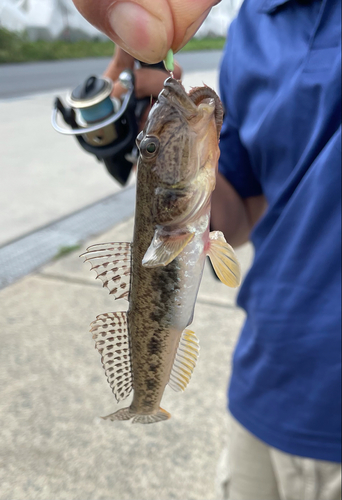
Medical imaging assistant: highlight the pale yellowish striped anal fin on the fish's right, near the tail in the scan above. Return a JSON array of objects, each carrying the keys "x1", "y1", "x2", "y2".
[{"x1": 169, "y1": 330, "x2": 199, "y2": 392}]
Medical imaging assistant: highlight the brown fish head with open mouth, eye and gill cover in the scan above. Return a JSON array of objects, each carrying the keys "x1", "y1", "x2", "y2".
[{"x1": 137, "y1": 78, "x2": 222, "y2": 224}]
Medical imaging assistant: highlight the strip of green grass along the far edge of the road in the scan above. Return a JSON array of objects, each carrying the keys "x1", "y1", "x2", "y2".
[{"x1": 0, "y1": 28, "x2": 225, "y2": 64}]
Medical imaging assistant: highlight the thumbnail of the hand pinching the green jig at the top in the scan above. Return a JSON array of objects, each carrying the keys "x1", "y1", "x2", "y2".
[{"x1": 109, "y1": 2, "x2": 168, "y2": 62}]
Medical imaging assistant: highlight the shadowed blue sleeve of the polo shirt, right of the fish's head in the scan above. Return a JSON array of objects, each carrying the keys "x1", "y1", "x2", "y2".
[{"x1": 219, "y1": 21, "x2": 262, "y2": 198}]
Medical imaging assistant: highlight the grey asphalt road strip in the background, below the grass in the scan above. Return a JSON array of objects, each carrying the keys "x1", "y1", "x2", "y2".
[{"x1": 0, "y1": 50, "x2": 222, "y2": 99}]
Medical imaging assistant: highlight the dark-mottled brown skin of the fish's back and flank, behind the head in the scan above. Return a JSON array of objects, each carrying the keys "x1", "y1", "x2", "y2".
[{"x1": 127, "y1": 161, "x2": 187, "y2": 414}]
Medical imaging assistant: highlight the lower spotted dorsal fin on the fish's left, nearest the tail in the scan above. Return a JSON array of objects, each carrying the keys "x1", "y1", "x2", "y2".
[{"x1": 90, "y1": 311, "x2": 133, "y2": 402}]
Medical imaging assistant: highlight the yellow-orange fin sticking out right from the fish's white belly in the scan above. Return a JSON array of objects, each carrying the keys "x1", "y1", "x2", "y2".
[{"x1": 207, "y1": 231, "x2": 241, "y2": 288}]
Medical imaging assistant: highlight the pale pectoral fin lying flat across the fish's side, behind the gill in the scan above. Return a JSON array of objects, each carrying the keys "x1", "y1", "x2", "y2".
[{"x1": 142, "y1": 229, "x2": 194, "y2": 267}]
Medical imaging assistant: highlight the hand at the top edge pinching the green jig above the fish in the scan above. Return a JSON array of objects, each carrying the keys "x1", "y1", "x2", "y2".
[{"x1": 73, "y1": 0, "x2": 220, "y2": 63}]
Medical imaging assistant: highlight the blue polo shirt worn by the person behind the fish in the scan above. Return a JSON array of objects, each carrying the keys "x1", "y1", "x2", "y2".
[{"x1": 219, "y1": 0, "x2": 341, "y2": 461}]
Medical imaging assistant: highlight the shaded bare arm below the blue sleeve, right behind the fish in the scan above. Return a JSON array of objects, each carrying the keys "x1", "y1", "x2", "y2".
[{"x1": 211, "y1": 173, "x2": 267, "y2": 247}]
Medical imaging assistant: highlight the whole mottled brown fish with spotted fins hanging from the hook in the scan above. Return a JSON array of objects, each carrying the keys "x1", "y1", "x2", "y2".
[{"x1": 83, "y1": 77, "x2": 241, "y2": 424}]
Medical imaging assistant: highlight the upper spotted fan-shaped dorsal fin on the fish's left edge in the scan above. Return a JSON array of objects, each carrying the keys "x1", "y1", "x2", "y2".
[{"x1": 80, "y1": 243, "x2": 131, "y2": 299}]
